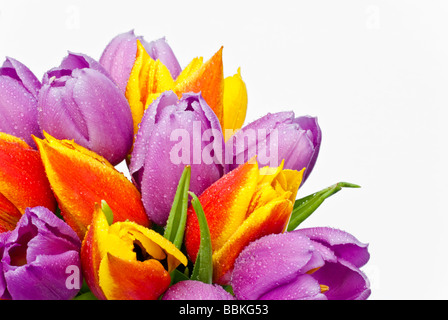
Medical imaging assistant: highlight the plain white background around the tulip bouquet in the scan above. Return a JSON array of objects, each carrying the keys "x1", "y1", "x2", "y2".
[{"x1": 0, "y1": 0, "x2": 448, "y2": 299}]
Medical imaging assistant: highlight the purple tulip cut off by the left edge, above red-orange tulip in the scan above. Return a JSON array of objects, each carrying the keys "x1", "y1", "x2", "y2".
[{"x1": 0, "y1": 58, "x2": 41, "y2": 146}]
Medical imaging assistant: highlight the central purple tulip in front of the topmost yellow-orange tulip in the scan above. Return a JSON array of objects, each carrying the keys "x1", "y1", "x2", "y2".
[{"x1": 129, "y1": 91, "x2": 225, "y2": 225}]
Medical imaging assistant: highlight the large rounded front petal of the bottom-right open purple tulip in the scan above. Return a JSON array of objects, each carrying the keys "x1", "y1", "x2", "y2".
[{"x1": 231, "y1": 232, "x2": 323, "y2": 300}]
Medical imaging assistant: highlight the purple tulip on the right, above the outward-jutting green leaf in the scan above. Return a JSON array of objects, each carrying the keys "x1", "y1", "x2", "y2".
[{"x1": 226, "y1": 111, "x2": 322, "y2": 183}]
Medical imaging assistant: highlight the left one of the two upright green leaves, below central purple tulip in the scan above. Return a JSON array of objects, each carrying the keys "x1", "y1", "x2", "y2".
[{"x1": 163, "y1": 166, "x2": 191, "y2": 250}]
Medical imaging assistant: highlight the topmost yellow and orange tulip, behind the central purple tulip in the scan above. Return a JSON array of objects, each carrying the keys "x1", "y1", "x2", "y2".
[{"x1": 126, "y1": 40, "x2": 247, "y2": 133}]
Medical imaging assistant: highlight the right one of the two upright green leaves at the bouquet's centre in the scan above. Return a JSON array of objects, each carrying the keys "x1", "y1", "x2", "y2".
[{"x1": 190, "y1": 192, "x2": 213, "y2": 283}]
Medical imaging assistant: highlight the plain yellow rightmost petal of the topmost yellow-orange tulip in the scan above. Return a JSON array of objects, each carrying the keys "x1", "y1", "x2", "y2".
[{"x1": 222, "y1": 68, "x2": 247, "y2": 141}]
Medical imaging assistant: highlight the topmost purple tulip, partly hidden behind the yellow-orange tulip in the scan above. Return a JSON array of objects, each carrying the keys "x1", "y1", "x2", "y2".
[{"x1": 100, "y1": 30, "x2": 181, "y2": 93}]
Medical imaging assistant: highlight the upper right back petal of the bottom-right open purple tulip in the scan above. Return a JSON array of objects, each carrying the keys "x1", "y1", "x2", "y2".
[{"x1": 293, "y1": 227, "x2": 370, "y2": 268}]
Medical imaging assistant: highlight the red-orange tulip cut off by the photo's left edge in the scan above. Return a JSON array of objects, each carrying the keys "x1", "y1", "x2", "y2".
[{"x1": 0, "y1": 132, "x2": 56, "y2": 232}]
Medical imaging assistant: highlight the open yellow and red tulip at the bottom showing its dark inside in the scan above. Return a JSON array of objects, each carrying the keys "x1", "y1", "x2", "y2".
[{"x1": 81, "y1": 205, "x2": 188, "y2": 300}]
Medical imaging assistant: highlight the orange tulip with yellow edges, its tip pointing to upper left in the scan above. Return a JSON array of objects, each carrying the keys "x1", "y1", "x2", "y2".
[{"x1": 34, "y1": 133, "x2": 150, "y2": 239}]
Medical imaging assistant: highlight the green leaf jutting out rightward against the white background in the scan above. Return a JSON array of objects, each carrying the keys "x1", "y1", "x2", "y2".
[{"x1": 287, "y1": 182, "x2": 360, "y2": 231}]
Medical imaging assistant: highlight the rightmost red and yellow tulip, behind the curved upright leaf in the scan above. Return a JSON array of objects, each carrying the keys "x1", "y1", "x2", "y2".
[{"x1": 185, "y1": 161, "x2": 303, "y2": 284}]
